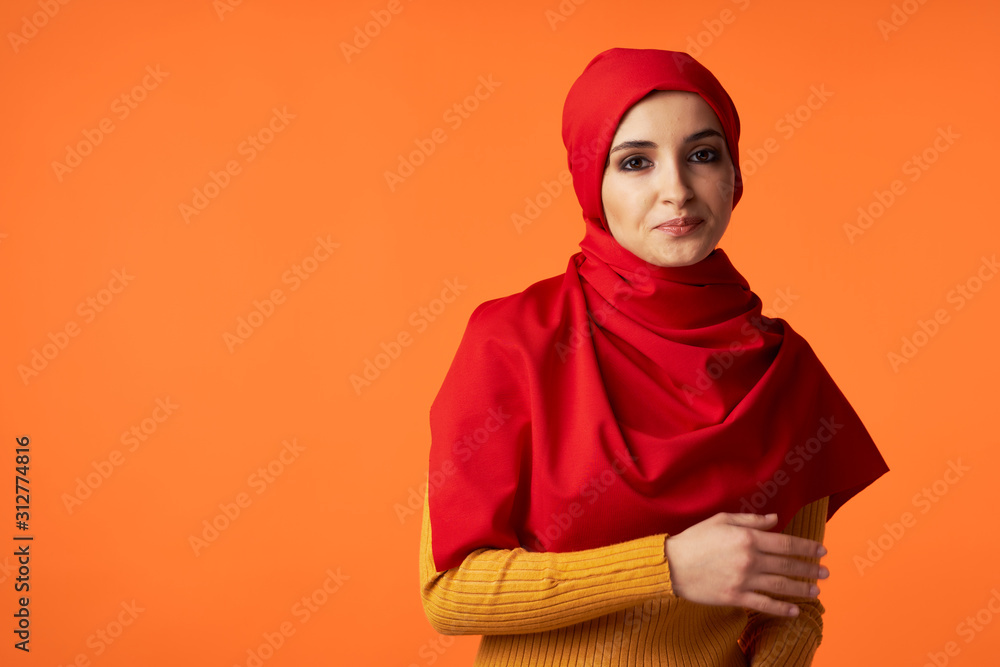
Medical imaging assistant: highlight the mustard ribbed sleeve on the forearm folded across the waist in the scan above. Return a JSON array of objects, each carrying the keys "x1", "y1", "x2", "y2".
[{"x1": 420, "y1": 486, "x2": 673, "y2": 635}]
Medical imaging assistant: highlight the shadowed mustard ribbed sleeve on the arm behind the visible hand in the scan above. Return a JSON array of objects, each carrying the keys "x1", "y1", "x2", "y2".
[{"x1": 740, "y1": 497, "x2": 829, "y2": 667}]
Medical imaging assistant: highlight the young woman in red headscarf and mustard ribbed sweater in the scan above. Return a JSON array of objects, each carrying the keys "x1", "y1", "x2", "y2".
[{"x1": 420, "y1": 49, "x2": 888, "y2": 666}]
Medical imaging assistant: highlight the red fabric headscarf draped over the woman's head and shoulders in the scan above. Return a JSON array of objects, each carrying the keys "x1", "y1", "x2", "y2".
[{"x1": 428, "y1": 49, "x2": 889, "y2": 571}]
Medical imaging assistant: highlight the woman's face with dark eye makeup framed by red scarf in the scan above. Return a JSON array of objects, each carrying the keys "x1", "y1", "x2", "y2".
[{"x1": 601, "y1": 90, "x2": 735, "y2": 266}]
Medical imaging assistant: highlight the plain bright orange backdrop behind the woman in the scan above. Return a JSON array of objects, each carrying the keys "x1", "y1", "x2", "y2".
[{"x1": 0, "y1": 0, "x2": 1000, "y2": 667}]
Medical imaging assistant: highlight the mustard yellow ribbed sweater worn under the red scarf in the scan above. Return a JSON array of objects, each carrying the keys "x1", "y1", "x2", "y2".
[{"x1": 420, "y1": 496, "x2": 828, "y2": 667}]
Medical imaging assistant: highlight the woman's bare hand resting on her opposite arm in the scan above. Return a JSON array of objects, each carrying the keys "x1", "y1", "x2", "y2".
[{"x1": 663, "y1": 512, "x2": 830, "y2": 616}]
